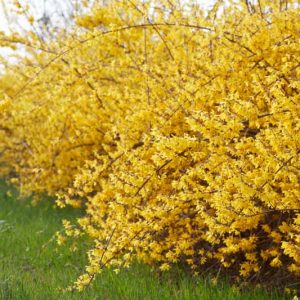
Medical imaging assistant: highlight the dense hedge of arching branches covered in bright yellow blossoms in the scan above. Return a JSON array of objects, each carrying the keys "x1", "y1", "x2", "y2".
[{"x1": 0, "y1": 0, "x2": 300, "y2": 289}]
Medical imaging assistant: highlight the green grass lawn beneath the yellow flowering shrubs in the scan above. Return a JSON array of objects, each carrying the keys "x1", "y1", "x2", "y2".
[{"x1": 0, "y1": 183, "x2": 292, "y2": 300}]
